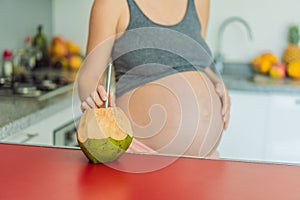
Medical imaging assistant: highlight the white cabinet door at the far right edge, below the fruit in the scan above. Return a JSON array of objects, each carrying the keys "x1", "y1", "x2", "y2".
[{"x1": 266, "y1": 95, "x2": 300, "y2": 163}]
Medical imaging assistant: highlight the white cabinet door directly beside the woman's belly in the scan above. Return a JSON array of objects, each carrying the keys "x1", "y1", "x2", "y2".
[{"x1": 218, "y1": 91, "x2": 269, "y2": 161}]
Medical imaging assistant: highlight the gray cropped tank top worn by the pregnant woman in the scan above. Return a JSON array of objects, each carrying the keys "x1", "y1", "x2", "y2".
[{"x1": 111, "y1": 0, "x2": 215, "y2": 97}]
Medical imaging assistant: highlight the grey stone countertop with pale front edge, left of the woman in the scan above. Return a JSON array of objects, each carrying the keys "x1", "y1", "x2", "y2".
[{"x1": 0, "y1": 84, "x2": 73, "y2": 140}]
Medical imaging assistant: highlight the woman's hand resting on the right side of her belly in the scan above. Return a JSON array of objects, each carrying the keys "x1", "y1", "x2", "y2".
[{"x1": 215, "y1": 82, "x2": 230, "y2": 129}]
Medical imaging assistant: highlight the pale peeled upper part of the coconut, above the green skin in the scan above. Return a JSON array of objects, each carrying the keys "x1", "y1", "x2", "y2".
[{"x1": 77, "y1": 107, "x2": 132, "y2": 143}]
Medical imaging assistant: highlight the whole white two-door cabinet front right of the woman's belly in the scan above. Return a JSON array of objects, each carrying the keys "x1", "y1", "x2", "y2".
[{"x1": 218, "y1": 91, "x2": 300, "y2": 163}]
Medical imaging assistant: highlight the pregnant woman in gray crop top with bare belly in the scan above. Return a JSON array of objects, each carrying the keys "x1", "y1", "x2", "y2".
[{"x1": 78, "y1": 0, "x2": 230, "y2": 157}]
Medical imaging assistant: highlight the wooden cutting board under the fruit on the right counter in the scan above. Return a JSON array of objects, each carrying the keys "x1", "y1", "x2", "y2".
[{"x1": 253, "y1": 74, "x2": 300, "y2": 86}]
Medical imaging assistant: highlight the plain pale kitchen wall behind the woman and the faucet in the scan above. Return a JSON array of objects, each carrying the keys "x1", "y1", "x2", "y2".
[{"x1": 0, "y1": 0, "x2": 300, "y2": 62}]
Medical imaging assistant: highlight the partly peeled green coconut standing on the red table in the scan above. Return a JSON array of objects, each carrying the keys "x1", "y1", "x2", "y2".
[{"x1": 77, "y1": 107, "x2": 132, "y2": 164}]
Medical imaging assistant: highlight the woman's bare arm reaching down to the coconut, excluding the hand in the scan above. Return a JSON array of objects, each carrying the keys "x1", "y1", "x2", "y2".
[{"x1": 78, "y1": 0, "x2": 121, "y2": 102}]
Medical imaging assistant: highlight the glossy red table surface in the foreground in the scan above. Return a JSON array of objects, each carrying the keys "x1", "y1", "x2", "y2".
[{"x1": 0, "y1": 144, "x2": 300, "y2": 200}]
